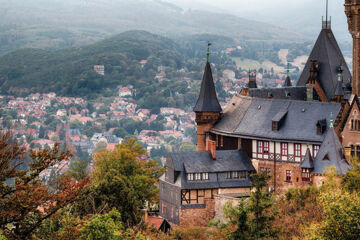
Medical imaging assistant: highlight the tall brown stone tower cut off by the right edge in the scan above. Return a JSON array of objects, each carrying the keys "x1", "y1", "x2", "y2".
[{"x1": 345, "y1": 0, "x2": 360, "y2": 96}]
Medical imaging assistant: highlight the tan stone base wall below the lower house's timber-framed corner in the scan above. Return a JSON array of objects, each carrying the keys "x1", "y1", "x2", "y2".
[{"x1": 180, "y1": 199, "x2": 215, "y2": 226}]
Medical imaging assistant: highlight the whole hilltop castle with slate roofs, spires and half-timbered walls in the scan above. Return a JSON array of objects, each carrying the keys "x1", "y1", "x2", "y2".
[{"x1": 159, "y1": 0, "x2": 360, "y2": 225}]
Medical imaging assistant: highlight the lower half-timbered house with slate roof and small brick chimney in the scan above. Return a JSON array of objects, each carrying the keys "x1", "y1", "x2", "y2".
[{"x1": 159, "y1": 146, "x2": 255, "y2": 225}]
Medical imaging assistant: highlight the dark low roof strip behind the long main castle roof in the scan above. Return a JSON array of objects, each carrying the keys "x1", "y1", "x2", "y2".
[{"x1": 249, "y1": 86, "x2": 306, "y2": 100}]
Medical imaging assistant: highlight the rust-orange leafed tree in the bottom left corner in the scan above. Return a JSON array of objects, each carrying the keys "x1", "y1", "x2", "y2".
[{"x1": 0, "y1": 133, "x2": 87, "y2": 239}]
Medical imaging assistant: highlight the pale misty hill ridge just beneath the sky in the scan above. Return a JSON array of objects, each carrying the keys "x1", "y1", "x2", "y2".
[{"x1": 0, "y1": 0, "x2": 306, "y2": 55}]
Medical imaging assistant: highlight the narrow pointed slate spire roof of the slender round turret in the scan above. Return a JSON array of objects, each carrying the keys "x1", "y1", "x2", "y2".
[{"x1": 193, "y1": 62, "x2": 222, "y2": 112}]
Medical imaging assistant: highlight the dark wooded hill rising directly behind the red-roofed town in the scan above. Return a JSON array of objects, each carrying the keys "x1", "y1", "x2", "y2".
[{"x1": 0, "y1": 31, "x2": 184, "y2": 102}]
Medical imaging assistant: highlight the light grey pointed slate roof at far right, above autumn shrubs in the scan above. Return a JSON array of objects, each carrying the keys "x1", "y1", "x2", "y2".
[{"x1": 312, "y1": 128, "x2": 351, "y2": 174}]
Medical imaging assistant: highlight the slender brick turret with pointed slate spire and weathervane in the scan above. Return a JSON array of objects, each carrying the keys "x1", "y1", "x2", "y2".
[{"x1": 193, "y1": 43, "x2": 222, "y2": 151}]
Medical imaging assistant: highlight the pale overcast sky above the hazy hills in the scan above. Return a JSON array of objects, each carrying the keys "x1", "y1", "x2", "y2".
[{"x1": 166, "y1": 0, "x2": 350, "y2": 40}]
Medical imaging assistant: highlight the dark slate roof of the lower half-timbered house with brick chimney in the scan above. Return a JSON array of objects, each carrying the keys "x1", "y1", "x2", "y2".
[{"x1": 169, "y1": 150, "x2": 255, "y2": 173}]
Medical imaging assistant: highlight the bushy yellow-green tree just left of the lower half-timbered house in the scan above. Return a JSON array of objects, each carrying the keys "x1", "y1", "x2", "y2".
[{"x1": 76, "y1": 139, "x2": 163, "y2": 226}]
